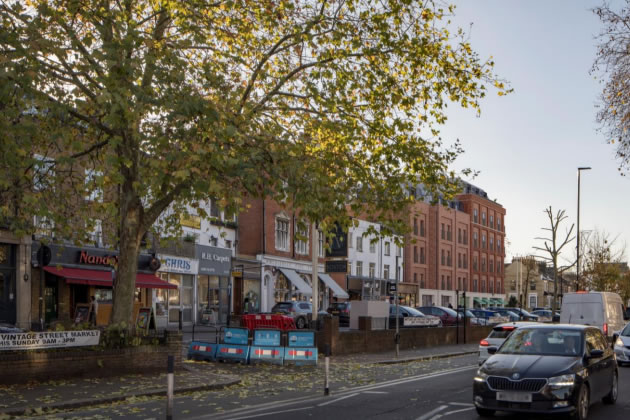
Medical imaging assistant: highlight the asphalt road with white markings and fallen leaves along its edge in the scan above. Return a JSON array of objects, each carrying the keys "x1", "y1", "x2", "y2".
[{"x1": 32, "y1": 356, "x2": 630, "y2": 420}]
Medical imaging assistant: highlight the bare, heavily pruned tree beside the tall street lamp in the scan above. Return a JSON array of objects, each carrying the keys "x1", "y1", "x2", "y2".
[{"x1": 534, "y1": 206, "x2": 575, "y2": 313}]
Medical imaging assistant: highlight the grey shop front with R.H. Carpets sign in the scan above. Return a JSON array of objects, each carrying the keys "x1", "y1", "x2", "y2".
[{"x1": 195, "y1": 244, "x2": 232, "y2": 324}]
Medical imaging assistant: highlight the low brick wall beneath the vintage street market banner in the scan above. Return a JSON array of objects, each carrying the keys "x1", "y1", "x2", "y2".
[{"x1": 0, "y1": 333, "x2": 182, "y2": 384}]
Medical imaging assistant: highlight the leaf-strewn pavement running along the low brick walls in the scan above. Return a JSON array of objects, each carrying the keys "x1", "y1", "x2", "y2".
[{"x1": 0, "y1": 344, "x2": 478, "y2": 419}]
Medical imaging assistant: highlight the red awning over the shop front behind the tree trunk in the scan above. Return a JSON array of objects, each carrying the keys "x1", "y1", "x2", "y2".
[{"x1": 44, "y1": 267, "x2": 177, "y2": 289}]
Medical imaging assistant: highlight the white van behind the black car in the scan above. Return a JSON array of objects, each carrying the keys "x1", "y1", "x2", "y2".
[{"x1": 560, "y1": 292, "x2": 624, "y2": 337}]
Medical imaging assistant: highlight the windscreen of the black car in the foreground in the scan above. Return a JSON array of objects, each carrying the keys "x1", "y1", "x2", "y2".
[{"x1": 497, "y1": 328, "x2": 582, "y2": 357}]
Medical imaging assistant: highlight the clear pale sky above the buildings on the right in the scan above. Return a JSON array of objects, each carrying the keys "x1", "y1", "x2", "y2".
[{"x1": 442, "y1": 0, "x2": 630, "y2": 262}]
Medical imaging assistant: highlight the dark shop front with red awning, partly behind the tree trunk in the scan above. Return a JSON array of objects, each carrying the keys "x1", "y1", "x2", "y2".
[{"x1": 31, "y1": 243, "x2": 173, "y2": 325}]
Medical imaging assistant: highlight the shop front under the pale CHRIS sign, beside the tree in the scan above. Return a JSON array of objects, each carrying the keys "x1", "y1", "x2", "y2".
[{"x1": 155, "y1": 255, "x2": 199, "y2": 327}]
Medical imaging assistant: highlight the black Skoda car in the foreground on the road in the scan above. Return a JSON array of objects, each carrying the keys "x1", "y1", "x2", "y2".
[{"x1": 473, "y1": 324, "x2": 618, "y2": 420}]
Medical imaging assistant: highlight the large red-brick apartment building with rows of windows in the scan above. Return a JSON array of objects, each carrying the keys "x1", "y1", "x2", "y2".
[{"x1": 404, "y1": 183, "x2": 505, "y2": 307}]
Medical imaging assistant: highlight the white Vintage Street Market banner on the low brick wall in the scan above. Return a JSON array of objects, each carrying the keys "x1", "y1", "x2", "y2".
[{"x1": 0, "y1": 330, "x2": 101, "y2": 351}]
